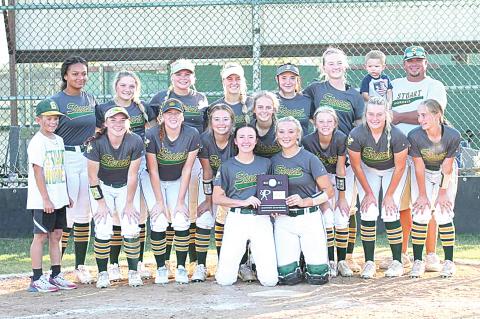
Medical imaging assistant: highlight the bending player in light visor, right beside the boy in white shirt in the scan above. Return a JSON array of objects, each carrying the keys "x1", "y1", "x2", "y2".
[{"x1": 85, "y1": 106, "x2": 144, "y2": 288}]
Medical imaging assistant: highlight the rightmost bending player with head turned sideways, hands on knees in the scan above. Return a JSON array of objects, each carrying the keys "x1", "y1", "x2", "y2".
[{"x1": 408, "y1": 99, "x2": 461, "y2": 277}]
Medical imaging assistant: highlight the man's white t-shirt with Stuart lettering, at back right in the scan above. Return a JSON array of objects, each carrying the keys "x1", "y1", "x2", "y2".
[{"x1": 392, "y1": 76, "x2": 447, "y2": 135}]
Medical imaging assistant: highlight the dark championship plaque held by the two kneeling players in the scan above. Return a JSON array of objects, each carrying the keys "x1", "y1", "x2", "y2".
[{"x1": 257, "y1": 175, "x2": 288, "y2": 215}]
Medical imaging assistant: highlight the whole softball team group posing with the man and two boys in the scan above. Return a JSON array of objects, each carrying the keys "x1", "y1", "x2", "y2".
[{"x1": 26, "y1": 46, "x2": 461, "y2": 292}]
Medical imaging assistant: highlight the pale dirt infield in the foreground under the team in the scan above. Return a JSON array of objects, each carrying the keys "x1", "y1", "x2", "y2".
[{"x1": 0, "y1": 262, "x2": 480, "y2": 319}]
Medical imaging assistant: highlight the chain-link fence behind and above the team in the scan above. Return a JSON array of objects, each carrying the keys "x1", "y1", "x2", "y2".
[{"x1": 0, "y1": 0, "x2": 480, "y2": 187}]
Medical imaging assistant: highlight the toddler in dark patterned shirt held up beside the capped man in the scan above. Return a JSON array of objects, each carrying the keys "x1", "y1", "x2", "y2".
[{"x1": 360, "y1": 50, "x2": 393, "y2": 107}]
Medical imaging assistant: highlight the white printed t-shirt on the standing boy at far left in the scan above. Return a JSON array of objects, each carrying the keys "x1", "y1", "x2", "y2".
[{"x1": 27, "y1": 132, "x2": 69, "y2": 209}]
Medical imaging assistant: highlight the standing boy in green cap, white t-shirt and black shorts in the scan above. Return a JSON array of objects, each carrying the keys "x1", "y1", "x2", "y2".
[{"x1": 27, "y1": 99, "x2": 77, "y2": 292}]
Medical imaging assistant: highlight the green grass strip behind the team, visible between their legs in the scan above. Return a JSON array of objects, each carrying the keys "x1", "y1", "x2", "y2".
[{"x1": 0, "y1": 234, "x2": 480, "y2": 275}]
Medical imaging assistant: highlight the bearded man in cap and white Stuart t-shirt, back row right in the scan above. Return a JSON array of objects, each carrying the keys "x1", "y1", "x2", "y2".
[{"x1": 388, "y1": 46, "x2": 447, "y2": 271}]
